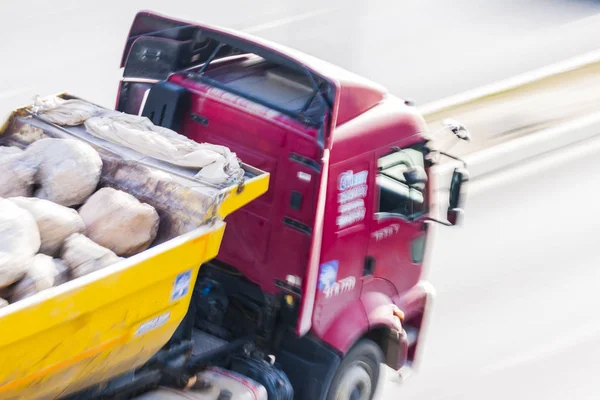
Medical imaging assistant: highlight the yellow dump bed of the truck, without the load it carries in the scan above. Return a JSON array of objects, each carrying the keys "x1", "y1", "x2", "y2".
[{"x1": 0, "y1": 95, "x2": 269, "y2": 400}]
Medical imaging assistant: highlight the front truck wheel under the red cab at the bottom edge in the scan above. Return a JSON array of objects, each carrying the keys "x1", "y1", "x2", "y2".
[{"x1": 327, "y1": 339, "x2": 383, "y2": 400}]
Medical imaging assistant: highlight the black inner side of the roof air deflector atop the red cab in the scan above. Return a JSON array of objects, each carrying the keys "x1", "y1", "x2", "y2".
[{"x1": 121, "y1": 12, "x2": 335, "y2": 126}]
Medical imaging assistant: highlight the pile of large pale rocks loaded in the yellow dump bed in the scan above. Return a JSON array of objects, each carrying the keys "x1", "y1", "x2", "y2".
[{"x1": 0, "y1": 138, "x2": 159, "y2": 305}]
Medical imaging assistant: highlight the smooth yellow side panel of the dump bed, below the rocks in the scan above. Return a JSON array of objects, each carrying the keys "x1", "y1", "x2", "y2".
[{"x1": 0, "y1": 221, "x2": 225, "y2": 399}]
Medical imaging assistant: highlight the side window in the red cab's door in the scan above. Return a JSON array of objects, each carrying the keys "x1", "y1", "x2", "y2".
[{"x1": 376, "y1": 145, "x2": 427, "y2": 218}]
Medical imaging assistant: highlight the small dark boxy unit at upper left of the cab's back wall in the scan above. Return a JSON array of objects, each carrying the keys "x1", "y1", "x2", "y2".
[{"x1": 142, "y1": 82, "x2": 190, "y2": 132}]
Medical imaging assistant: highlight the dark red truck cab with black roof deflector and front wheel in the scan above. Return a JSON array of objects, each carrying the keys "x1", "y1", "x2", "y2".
[{"x1": 117, "y1": 12, "x2": 466, "y2": 400}]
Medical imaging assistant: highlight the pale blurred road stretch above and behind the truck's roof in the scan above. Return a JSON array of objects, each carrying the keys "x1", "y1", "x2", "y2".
[{"x1": 0, "y1": 0, "x2": 600, "y2": 107}]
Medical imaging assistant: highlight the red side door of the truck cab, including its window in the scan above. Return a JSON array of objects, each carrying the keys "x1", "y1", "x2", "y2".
[{"x1": 363, "y1": 143, "x2": 429, "y2": 296}]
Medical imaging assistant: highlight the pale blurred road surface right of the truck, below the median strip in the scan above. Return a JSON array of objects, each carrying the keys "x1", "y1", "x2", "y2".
[{"x1": 382, "y1": 128, "x2": 600, "y2": 400}]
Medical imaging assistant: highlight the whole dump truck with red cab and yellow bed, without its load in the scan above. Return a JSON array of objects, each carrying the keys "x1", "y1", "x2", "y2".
[{"x1": 0, "y1": 11, "x2": 469, "y2": 400}]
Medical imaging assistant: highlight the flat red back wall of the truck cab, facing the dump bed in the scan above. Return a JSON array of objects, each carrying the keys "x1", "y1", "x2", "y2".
[{"x1": 171, "y1": 75, "x2": 320, "y2": 293}]
